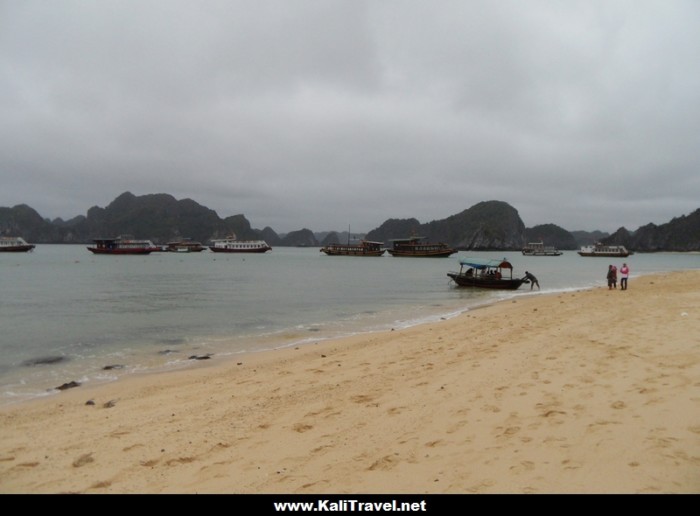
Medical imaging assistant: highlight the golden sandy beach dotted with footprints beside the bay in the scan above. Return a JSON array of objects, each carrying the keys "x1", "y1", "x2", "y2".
[{"x1": 0, "y1": 271, "x2": 700, "y2": 494}]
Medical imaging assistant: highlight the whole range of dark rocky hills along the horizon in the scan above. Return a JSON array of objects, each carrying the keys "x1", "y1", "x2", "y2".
[{"x1": 0, "y1": 192, "x2": 700, "y2": 252}]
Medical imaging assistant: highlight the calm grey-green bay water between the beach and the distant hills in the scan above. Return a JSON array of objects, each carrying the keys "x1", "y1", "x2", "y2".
[{"x1": 0, "y1": 245, "x2": 700, "y2": 404}]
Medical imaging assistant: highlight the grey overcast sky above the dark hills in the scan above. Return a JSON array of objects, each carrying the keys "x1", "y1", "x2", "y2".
[{"x1": 0, "y1": 0, "x2": 700, "y2": 232}]
